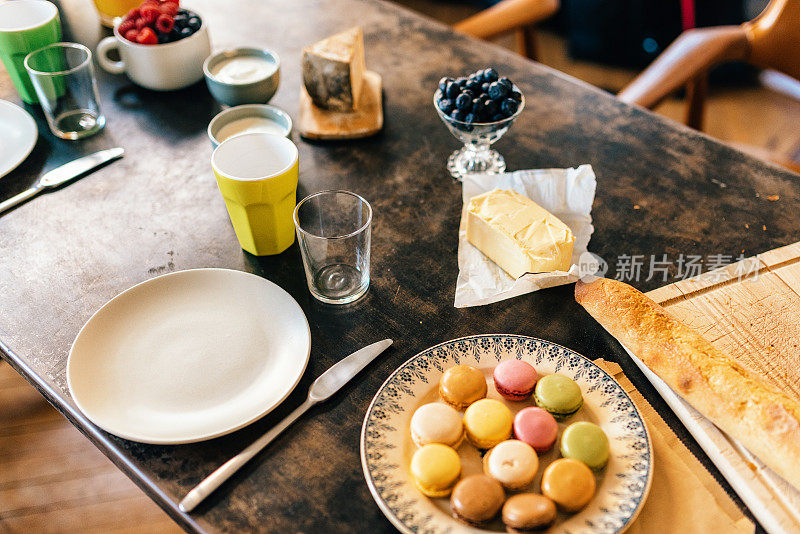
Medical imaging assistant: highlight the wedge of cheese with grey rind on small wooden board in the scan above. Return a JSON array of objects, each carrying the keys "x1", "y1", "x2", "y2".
[{"x1": 303, "y1": 26, "x2": 366, "y2": 111}]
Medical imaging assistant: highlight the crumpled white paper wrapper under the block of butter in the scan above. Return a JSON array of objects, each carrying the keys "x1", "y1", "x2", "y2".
[{"x1": 454, "y1": 165, "x2": 597, "y2": 308}]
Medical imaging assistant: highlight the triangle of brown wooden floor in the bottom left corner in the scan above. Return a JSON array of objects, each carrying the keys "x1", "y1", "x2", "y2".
[{"x1": 0, "y1": 362, "x2": 181, "y2": 534}]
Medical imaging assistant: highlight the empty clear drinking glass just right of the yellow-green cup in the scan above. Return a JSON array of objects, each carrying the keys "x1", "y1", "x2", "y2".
[{"x1": 294, "y1": 191, "x2": 372, "y2": 304}]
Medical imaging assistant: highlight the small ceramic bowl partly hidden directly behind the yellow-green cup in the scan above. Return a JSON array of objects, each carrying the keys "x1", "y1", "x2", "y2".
[{"x1": 208, "y1": 104, "x2": 292, "y2": 148}]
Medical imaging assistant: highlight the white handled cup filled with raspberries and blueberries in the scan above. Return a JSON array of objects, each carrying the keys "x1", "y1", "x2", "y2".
[{"x1": 97, "y1": 0, "x2": 211, "y2": 91}]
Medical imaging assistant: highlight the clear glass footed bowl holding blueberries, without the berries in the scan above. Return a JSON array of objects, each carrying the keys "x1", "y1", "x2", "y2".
[{"x1": 433, "y1": 85, "x2": 525, "y2": 181}]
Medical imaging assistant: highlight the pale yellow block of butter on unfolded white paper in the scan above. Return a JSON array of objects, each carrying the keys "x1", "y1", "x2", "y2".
[{"x1": 467, "y1": 189, "x2": 575, "y2": 279}]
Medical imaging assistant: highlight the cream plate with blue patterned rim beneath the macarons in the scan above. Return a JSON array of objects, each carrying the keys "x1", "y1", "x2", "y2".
[{"x1": 361, "y1": 334, "x2": 653, "y2": 534}]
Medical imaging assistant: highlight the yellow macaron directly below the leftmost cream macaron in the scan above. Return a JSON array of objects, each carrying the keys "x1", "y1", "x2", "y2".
[{"x1": 411, "y1": 443, "x2": 461, "y2": 497}]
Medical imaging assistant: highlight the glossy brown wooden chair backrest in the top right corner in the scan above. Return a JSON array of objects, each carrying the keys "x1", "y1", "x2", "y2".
[{"x1": 743, "y1": 0, "x2": 800, "y2": 80}]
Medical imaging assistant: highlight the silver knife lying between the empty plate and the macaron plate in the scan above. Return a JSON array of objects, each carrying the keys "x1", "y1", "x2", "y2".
[{"x1": 178, "y1": 339, "x2": 392, "y2": 512}]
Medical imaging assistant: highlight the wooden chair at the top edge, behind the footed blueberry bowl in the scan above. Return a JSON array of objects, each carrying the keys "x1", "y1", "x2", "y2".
[{"x1": 453, "y1": 0, "x2": 559, "y2": 59}]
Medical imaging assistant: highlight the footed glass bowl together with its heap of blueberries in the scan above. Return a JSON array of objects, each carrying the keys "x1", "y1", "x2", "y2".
[{"x1": 433, "y1": 67, "x2": 525, "y2": 181}]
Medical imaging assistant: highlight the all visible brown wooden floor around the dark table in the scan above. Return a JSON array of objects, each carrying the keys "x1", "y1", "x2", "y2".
[{"x1": 0, "y1": 4, "x2": 800, "y2": 534}]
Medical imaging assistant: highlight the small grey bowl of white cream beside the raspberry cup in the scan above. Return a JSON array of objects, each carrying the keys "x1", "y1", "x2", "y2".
[{"x1": 203, "y1": 47, "x2": 281, "y2": 106}]
